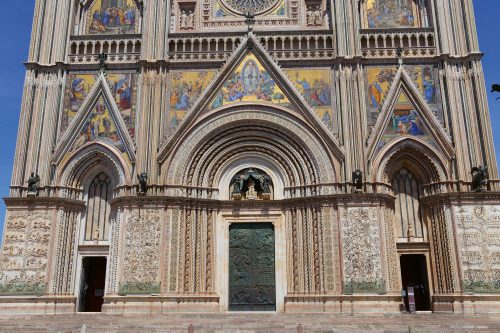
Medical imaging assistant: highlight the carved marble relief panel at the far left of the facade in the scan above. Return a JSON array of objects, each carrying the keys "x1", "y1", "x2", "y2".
[{"x1": 0, "y1": 211, "x2": 52, "y2": 295}]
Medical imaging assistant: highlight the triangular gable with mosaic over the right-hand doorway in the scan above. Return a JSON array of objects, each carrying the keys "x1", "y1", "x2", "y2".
[{"x1": 368, "y1": 66, "x2": 454, "y2": 159}]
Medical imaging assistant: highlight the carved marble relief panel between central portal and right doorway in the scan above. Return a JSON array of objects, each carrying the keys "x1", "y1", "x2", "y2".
[{"x1": 341, "y1": 208, "x2": 385, "y2": 294}]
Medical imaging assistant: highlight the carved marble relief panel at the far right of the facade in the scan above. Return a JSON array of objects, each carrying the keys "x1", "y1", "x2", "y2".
[{"x1": 455, "y1": 205, "x2": 500, "y2": 293}]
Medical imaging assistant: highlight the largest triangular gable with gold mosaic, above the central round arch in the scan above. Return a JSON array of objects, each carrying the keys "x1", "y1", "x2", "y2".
[{"x1": 159, "y1": 33, "x2": 344, "y2": 161}]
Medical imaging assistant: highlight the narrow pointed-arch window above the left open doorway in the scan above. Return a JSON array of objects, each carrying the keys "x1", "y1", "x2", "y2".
[{"x1": 85, "y1": 173, "x2": 112, "y2": 241}]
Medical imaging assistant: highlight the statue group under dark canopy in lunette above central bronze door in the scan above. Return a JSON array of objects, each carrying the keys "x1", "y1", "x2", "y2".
[{"x1": 231, "y1": 168, "x2": 272, "y2": 200}]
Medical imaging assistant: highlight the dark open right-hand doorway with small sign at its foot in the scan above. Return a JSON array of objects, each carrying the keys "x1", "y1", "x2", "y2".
[{"x1": 400, "y1": 254, "x2": 431, "y2": 311}]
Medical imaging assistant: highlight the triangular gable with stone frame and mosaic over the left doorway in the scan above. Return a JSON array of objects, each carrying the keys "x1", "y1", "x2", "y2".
[{"x1": 53, "y1": 74, "x2": 135, "y2": 164}]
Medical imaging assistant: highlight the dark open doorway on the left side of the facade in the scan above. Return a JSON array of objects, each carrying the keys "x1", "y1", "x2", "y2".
[{"x1": 78, "y1": 257, "x2": 106, "y2": 312}]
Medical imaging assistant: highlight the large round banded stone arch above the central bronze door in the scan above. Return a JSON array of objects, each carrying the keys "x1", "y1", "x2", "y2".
[{"x1": 162, "y1": 105, "x2": 340, "y2": 199}]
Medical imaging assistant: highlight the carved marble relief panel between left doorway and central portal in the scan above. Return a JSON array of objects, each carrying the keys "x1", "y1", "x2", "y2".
[{"x1": 119, "y1": 209, "x2": 161, "y2": 295}]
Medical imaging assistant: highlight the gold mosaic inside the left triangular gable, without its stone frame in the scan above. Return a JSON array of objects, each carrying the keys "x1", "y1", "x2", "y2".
[{"x1": 72, "y1": 97, "x2": 130, "y2": 162}]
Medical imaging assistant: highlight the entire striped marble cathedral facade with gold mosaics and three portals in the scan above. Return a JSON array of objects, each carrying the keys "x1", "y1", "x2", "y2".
[{"x1": 0, "y1": 0, "x2": 500, "y2": 314}]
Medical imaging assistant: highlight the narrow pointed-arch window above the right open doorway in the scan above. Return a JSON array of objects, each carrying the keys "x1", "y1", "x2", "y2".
[{"x1": 392, "y1": 168, "x2": 424, "y2": 238}]
